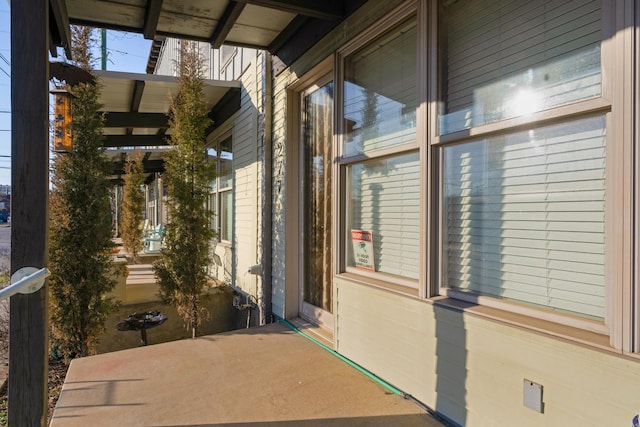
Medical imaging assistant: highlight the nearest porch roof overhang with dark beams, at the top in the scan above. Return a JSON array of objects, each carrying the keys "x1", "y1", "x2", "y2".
[{"x1": 49, "y1": 0, "x2": 366, "y2": 68}]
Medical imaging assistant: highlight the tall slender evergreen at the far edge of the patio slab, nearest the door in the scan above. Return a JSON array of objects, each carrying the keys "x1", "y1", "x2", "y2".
[{"x1": 154, "y1": 42, "x2": 215, "y2": 337}]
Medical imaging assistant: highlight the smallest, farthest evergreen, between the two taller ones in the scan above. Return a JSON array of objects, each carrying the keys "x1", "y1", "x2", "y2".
[{"x1": 120, "y1": 150, "x2": 144, "y2": 262}]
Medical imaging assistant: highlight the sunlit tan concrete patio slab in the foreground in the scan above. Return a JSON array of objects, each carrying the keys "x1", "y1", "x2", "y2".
[{"x1": 50, "y1": 323, "x2": 442, "y2": 427}]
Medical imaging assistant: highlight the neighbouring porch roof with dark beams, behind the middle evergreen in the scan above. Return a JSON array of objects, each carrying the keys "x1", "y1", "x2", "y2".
[{"x1": 94, "y1": 71, "x2": 240, "y2": 181}]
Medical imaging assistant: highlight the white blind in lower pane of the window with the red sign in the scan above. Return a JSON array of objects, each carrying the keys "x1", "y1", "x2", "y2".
[{"x1": 347, "y1": 153, "x2": 420, "y2": 280}]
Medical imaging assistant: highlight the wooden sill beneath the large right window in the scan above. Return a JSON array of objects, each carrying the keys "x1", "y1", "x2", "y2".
[{"x1": 429, "y1": 296, "x2": 620, "y2": 359}]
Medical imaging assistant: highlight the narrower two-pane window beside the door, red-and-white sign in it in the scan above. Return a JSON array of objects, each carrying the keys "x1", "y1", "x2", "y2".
[{"x1": 341, "y1": 12, "x2": 421, "y2": 288}]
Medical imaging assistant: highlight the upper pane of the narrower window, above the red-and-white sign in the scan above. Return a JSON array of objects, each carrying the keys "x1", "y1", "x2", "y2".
[{"x1": 343, "y1": 20, "x2": 417, "y2": 156}]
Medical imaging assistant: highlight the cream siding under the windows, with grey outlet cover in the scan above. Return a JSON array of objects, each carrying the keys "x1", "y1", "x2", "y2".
[{"x1": 335, "y1": 278, "x2": 640, "y2": 427}]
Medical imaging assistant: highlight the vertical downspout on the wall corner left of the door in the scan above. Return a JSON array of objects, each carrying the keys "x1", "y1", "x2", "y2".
[{"x1": 259, "y1": 50, "x2": 273, "y2": 325}]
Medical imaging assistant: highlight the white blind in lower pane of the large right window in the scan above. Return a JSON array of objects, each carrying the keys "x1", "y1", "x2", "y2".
[{"x1": 444, "y1": 117, "x2": 605, "y2": 319}]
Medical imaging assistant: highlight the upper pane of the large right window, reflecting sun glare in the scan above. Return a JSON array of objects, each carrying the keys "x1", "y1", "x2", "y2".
[{"x1": 439, "y1": 0, "x2": 602, "y2": 133}]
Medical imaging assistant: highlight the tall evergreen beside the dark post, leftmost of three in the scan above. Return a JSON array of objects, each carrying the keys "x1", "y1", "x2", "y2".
[{"x1": 49, "y1": 27, "x2": 116, "y2": 357}]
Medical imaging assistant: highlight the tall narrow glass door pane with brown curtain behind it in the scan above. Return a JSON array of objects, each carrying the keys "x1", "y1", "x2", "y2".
[{"x1": 300, "y1": 77, "x2": 333, "y2": 326}]
